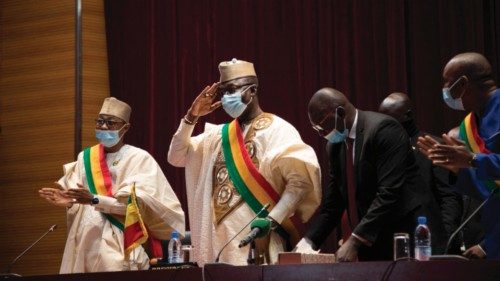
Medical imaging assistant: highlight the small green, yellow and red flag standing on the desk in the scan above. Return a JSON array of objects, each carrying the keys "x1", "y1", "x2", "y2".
[{"x1": 123, "y1": 183, "x2": 148, "y2": 260}]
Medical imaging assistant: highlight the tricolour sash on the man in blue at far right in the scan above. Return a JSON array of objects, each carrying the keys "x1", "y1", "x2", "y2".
[{"x1": 460, "y1": 112, "x2": 500, "y2": 192}]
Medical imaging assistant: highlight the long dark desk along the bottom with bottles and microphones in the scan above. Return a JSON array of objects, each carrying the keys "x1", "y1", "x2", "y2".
[{"x1": 13, "y1": 261, "x2": 500, "y2": 281}]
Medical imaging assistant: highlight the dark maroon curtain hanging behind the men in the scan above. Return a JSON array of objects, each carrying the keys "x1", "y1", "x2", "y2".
[{"x1": 105, "y1": 0, "x2": 500, "y2": 249}]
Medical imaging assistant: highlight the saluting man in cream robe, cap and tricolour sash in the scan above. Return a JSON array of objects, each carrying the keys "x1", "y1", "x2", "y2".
[{"x1": 168, "y1": 59, "x2": 321, "y2": 265}]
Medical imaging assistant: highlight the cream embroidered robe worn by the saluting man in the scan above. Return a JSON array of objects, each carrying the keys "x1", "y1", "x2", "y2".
[{"x1": 168, "y1": 115, "x2": 321, "y2": 265}]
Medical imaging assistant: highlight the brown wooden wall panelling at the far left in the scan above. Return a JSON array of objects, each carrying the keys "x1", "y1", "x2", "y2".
[{"x1": 0, "y1": 0, "x2": 109, "y2": 275}]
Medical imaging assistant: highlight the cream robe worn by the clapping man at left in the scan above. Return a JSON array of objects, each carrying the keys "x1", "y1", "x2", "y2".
[{"x1": 59, "y1": 145, "x2": 185, "y2": 273}]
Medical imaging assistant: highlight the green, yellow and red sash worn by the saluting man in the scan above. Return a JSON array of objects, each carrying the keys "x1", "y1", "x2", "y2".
[{"x1": 222, "y1": 119, "x2": 304, "y2": 245}]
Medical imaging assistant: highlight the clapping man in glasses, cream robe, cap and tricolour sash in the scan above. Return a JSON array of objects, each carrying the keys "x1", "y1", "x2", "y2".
[{"x1": 39, "y1": 98, "x2": 184, "y2": 273}]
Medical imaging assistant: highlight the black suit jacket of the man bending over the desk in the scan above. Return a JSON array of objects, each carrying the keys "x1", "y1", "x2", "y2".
[{"x1": 306, "y1": 110, "x2": 421, "y2": 260}]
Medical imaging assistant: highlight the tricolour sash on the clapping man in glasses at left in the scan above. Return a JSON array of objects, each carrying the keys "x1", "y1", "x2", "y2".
[{"x1": 83, "y1": 144, "x2": 124, "y2": 231}]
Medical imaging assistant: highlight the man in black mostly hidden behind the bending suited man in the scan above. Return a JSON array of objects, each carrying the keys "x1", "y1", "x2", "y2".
[{"x1": 378, "y1": 93, "x2": 463, "y2": 254}]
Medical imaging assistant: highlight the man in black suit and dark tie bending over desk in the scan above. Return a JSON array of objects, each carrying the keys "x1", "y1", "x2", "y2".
[{"x1": 298, "y1": 88, "x2": 421, "y2": 261}]
